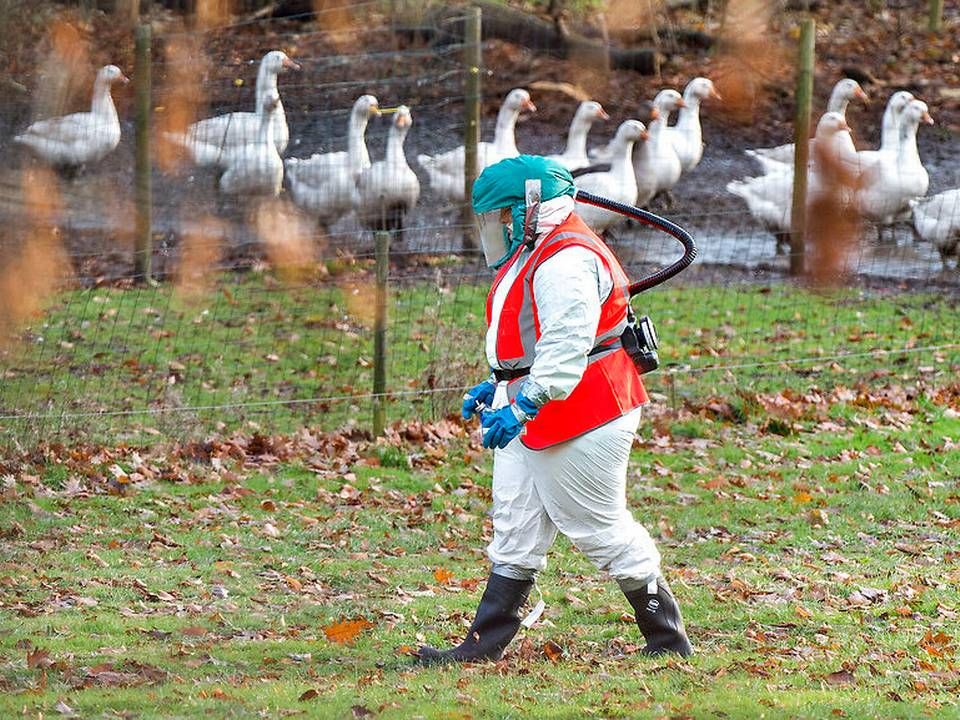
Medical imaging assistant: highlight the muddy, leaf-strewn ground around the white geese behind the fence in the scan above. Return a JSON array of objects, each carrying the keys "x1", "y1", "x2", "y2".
[{"x1": 0, "y1": 3, "x2": 960, "y2": 283}]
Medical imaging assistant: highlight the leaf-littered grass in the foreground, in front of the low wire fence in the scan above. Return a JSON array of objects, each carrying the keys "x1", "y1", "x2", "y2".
[{"x1": 0, "y1": 379, "x2": 960, "y2": 715}]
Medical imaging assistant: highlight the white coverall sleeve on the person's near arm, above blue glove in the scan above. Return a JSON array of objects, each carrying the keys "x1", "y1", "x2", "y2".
[{"x1": 530, "y1": 245, "x2": 613, "y2": 400}]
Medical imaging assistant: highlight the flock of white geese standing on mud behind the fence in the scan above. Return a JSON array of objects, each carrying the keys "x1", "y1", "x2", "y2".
[{"x1": 14, "y1": 50, "x2": 960, "y2": 264}]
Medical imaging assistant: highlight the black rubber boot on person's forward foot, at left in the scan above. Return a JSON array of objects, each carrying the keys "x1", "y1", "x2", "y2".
[{"x1": 417, "y1": 573, "x2": 533, "y2": 665}]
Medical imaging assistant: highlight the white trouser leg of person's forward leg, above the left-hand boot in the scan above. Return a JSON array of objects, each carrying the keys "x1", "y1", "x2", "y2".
[{"x1": 487, "y1": 440, "x2": 557, "y2": 575}]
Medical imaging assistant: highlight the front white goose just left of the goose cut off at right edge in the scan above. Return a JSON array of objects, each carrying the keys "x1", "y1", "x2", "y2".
[{"x1": 857, "y1": 100, "x2": 933, "y2": 226}]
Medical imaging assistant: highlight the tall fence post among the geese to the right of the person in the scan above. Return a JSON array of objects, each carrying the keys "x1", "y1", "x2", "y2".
[{"x1": 790, "y1": 18, "x2": 816, "y2": 275}]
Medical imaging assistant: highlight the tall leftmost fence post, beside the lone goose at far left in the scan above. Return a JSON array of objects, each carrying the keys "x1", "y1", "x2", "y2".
[{"x1": 133, "y1": 23, "x2": 153, "y2": 283}]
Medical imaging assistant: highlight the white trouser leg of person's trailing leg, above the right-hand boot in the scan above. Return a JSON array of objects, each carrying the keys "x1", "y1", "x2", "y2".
[{"x1": 524, "y1": 408, "x2": 660, "y2": 581}]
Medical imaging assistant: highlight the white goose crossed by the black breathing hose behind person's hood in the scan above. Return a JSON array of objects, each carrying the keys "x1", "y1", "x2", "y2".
[{"x1": 573, "y1": 120, "x2": 647, "y2": 233}]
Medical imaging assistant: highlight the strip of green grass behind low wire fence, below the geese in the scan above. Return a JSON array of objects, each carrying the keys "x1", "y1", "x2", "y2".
[{"x1": 0, "y1": 261, "x2": 960, "y2": 446}]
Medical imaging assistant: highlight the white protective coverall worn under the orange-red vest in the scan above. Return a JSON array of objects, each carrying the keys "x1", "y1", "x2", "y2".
[{"x1": 486, "y1": 195, "x2": 660, "y2": 591}]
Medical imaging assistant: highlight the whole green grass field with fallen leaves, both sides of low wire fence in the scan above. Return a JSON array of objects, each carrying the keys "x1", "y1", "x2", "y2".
[{"x1": 0, "y1": 276, "x2": 960, "y2": 719}]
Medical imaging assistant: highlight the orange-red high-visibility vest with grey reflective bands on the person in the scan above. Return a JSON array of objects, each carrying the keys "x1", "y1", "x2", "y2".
[{"x1": 487, "y1": 213, "x2": 647, "y2": 450}]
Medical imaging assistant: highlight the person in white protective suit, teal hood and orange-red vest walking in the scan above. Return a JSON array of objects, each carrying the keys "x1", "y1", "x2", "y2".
[{"x1": 417, "y1": 155, "x2": 692, "y2": 664}]
